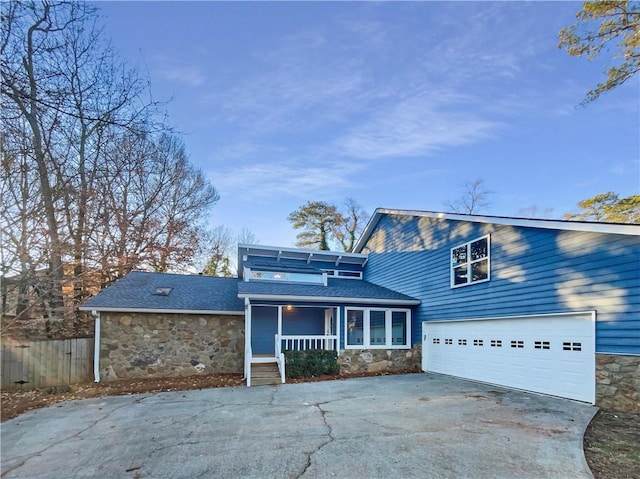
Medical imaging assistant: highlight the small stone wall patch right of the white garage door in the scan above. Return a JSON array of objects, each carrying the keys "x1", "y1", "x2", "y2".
[{"x1": 596, "y1": 354, "x2": 640, "y2": 413}]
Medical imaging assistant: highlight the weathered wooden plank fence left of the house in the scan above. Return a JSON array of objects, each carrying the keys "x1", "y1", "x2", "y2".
[{"x1": 0, "y1": 338, "x2": 93, "y2": 389}]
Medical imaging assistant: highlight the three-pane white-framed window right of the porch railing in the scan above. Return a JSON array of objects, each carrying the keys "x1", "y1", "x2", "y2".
[{"x1": 345, "y1": 308, "x2": 411, "y2": 349}]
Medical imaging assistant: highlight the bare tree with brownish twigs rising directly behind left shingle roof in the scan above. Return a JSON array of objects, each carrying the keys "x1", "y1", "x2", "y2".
[{"x1": 91, "y1": 134, "x2": 218, "y2": 283}]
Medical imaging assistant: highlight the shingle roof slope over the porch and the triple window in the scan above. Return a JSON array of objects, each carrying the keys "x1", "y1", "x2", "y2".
[{"x1": 238, "y1": 278, "x2": 420, "y2": 304}]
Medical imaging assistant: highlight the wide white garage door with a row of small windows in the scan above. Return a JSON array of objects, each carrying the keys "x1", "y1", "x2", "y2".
[{"x1": 422, "y1": 313, "x2": 595, "y2": 404}]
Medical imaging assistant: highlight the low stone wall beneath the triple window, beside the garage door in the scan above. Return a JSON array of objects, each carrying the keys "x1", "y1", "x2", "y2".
[{"x1": 338, "y1": 344, "x2": 422, "y2": 374}]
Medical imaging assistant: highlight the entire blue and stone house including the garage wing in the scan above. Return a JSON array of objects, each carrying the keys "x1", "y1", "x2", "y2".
[{"x1": 81, "y1": 209, "x2": 640, "y2": 410}]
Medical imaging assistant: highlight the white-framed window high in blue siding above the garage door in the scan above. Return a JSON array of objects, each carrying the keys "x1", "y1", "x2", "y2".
[{"x1": 451, "y1": 235, "x2": 491, "y2": 288}]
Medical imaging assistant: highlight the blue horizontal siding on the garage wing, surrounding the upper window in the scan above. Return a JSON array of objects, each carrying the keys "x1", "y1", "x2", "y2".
[{"x1": 362, "y1": 215, "x2": 640, "y2": 354}]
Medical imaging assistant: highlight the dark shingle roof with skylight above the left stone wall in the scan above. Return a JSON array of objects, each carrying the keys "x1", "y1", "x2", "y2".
[{"x1": 80, "y1": 271, "x2": 244, "y2": 313}]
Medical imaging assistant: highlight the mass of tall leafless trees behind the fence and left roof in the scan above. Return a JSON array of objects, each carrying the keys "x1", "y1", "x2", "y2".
[{"x1": 0, "y1": 1, "x2": 218, "y2": 334}]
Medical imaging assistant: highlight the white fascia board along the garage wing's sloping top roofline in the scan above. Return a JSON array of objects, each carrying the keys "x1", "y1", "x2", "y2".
[{"x1": 353, "y1": 208, "x2": 640, "y2": 251}]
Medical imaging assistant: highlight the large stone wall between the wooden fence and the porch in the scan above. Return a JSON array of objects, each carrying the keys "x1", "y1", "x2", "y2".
[{"x1": 100, "y1": 313, "x2": 244, "y2": 381}]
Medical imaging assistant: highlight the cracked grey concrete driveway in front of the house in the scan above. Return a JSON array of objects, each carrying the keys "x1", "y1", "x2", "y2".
[{"x1": 1, "y1": 374, "x2": 596, "y2": 479}]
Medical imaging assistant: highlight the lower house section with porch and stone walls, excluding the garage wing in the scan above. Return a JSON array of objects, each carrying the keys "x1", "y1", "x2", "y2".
[{"x1": 81, "y1": 248, "x2": 420, "y2": 385}]
